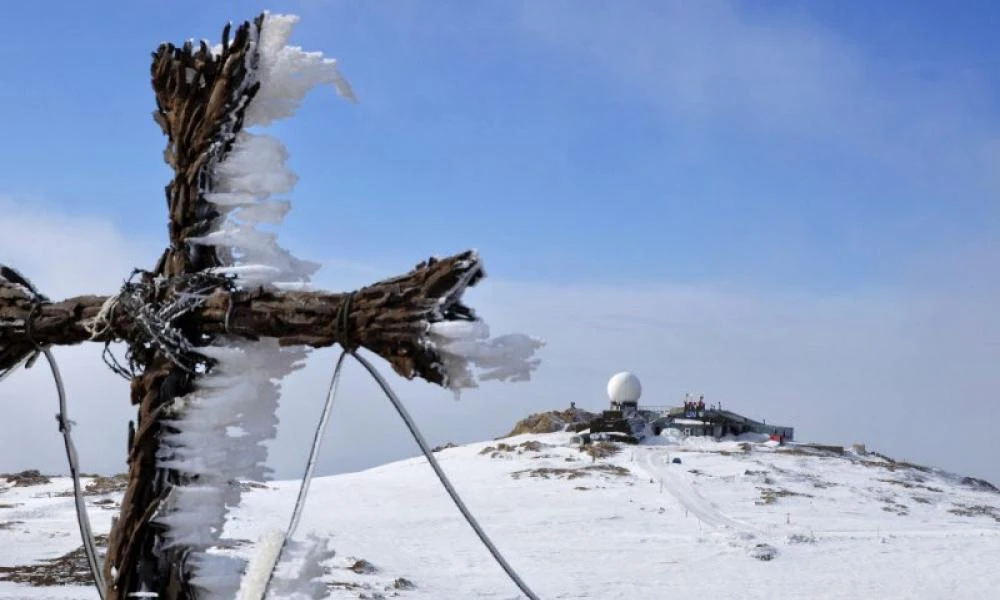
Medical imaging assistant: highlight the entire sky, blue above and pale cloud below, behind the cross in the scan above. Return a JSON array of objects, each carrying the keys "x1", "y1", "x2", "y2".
[{"x1": 0, "y1": 0, "x2": 1000, "y2": 480}]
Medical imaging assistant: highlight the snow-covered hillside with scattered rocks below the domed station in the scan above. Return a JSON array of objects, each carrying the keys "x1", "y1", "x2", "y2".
[{"x1": 0, "y1": 433, "x2": 1000, "y2": 600}]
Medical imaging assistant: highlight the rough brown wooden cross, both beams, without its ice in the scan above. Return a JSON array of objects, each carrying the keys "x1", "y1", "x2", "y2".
[{"x1": 0, "y1": 15, "x2": 534, "y2": 600}]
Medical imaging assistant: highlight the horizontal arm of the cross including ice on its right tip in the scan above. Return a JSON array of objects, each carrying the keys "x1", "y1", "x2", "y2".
[{"x1": 0, "y1": 251, "x2": 541, "y2": 390}]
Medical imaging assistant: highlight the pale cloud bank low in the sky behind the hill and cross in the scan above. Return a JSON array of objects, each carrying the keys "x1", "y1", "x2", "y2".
[{"x1": 0, "y1": 204, "x2": 1000, "y2": 488}]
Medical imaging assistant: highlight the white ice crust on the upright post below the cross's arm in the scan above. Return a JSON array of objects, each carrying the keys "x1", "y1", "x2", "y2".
[{"x1": 155, "y1": 338, "x2": 307, "y2": 598}]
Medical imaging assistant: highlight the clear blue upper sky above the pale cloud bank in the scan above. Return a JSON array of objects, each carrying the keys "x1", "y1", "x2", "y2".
[{"x1": 0, "y1": 2, "x2": 1000, "y2": 290}]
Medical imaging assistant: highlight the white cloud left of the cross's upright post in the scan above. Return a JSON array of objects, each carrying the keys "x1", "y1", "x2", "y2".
[{"x1": 0, "y1": 197, "x2": 158, "y2": 472}]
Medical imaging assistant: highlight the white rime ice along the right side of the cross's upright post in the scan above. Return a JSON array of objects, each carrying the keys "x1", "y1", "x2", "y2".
[{"x1": 161, "y1": 14, "x2": 353, "y2": 600}]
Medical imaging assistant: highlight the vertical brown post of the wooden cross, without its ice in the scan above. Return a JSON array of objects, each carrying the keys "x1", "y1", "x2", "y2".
[{"x1": 104, "y1": 15, "x2": 284, "y2": 600}]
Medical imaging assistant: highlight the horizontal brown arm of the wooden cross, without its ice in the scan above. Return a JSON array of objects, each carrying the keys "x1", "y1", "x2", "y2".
[{"x1": 0, "y1": 251, "x2": 483, "y2": 384}]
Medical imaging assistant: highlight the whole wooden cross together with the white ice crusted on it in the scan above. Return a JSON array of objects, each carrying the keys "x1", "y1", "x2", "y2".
[{"x1": 0, "y1": 13, "x2": 542, "y2": 600}]
